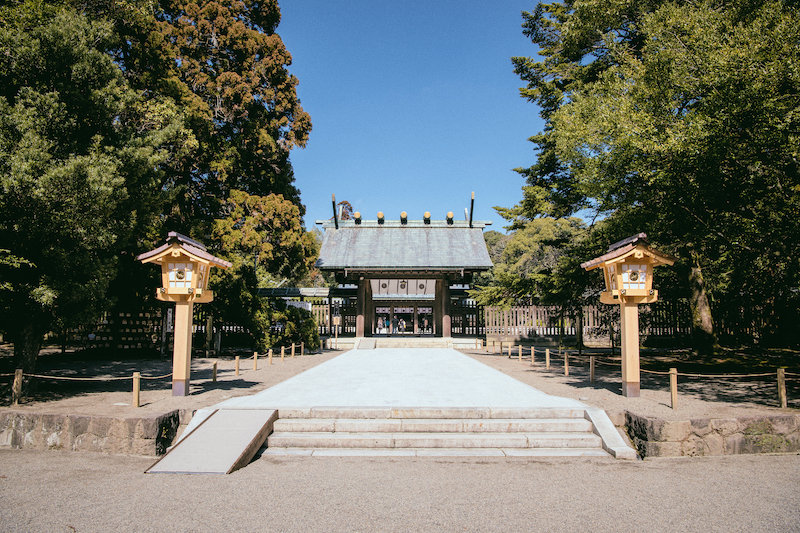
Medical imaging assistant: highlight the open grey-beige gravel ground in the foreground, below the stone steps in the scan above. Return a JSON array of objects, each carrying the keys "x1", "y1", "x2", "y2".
[{"x1": 0, "y1": 450, "x2": 800, "y2": 532}]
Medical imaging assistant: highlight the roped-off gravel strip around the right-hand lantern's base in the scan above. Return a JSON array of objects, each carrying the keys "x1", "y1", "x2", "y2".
[{"x1": 463, "y1": 351, "x2": 800, "y2": 423}]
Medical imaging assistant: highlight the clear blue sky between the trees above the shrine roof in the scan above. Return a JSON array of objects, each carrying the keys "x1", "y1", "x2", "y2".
[{"x1": 278, "y1": 0, "x2": 543, "y2": 231}]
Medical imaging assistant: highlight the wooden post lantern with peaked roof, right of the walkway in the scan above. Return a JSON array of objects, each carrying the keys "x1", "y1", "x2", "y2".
[{"x1": 581, "y1": 233, "x2": 675, "y2": 397}]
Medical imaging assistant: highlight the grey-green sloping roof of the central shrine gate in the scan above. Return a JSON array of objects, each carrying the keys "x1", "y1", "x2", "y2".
[{"x1": 317, "y1": 221, "x2": 492, "y2": 270}]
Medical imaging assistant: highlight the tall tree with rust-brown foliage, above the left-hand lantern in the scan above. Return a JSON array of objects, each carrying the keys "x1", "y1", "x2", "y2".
[{"x1": 146, "y1": 0, "x2": 311, "y2": 227}]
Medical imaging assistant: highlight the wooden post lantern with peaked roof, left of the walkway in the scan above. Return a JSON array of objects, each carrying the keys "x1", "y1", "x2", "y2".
[{"x1": 136, "y1": 231, "x2": 231, "y2": 396}]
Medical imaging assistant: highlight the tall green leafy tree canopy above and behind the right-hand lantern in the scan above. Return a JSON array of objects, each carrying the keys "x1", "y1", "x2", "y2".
[{"x1": 514, "y1": 0, "x2": 800, "y2": 348}]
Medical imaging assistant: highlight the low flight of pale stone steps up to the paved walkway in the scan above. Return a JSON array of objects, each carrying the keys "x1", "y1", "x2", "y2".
[{"x1": 264, "y1": 407, "x2": 632, "y2": 457}]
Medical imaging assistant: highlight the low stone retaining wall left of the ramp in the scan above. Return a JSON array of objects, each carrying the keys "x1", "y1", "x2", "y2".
[{"x1": 0, "y1": 410, "x2": 192, "y2": 456}]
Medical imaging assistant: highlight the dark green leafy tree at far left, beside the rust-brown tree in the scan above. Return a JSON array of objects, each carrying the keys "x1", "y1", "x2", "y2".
[{"x1": 0, "y1": 8, "x2": 186, "y2": 371}]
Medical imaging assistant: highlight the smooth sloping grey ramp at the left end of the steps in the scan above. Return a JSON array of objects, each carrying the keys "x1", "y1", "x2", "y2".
[{"x1": 145, "y1": 409, "x2": 278, "y2": 474}]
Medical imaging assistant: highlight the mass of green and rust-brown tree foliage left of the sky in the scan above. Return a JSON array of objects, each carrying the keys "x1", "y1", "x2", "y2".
[{"x1": 0, "y1": 0, "x2": 316, "y2": 370}]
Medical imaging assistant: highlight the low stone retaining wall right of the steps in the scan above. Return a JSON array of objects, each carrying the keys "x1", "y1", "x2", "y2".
[{"x1": 625, "y1": 411, "x2": 800, "y2": 457}]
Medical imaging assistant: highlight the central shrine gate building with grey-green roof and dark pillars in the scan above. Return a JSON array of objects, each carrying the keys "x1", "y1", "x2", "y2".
[{"x1": 316, "y1": 204, "x2": 492, "y2": 337}]
